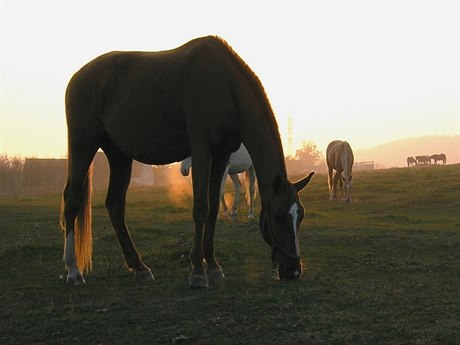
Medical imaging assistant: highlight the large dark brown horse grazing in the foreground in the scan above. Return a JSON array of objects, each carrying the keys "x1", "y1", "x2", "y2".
[{"x1": 61, "y1": 36, "x2": 313, "y2": 287}]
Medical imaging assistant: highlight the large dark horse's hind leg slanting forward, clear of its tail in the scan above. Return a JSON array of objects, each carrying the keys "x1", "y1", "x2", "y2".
[{"x1": 105, "y1": 148, "x2": 154, "y2": 281}]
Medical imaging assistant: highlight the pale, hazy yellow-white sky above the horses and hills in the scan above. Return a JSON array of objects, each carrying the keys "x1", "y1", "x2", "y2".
[{"x1": 0, "y1": 0, "x2": 460, "y2": 158}]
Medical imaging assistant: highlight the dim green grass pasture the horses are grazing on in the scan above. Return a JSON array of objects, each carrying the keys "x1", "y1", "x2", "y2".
[{"x1": 0, "y1": 165, "x2": 460, "y2": 345}]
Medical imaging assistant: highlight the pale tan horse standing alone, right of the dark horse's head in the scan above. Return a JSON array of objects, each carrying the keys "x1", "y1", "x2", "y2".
[{"x1": 326, "y1": 140, "x2": 354, "y2": 202}]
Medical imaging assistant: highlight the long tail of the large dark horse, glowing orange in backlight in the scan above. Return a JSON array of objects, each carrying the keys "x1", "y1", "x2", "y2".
[{"x1": 61, "y1": 159, "x2": 93, "y2": 272}]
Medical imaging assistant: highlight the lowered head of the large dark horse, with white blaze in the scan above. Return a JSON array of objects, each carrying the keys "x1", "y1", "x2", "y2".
[{"x1": 260, "y1": 173, "x2": 313, "y2": 280}]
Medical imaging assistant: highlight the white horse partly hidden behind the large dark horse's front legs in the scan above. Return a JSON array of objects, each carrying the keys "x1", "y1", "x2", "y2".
[{"x1": 180, "y1": 144, "x2": 256, "y2": 218}]
